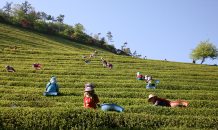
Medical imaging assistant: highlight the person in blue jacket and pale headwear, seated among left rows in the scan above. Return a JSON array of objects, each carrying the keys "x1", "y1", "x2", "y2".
[{"x1": 45, "y1": 77, "x2": 59, "y2": 92}]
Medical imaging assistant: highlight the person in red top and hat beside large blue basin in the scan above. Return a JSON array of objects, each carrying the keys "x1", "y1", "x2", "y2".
[{"x1": 83, "y1": 83, "x2": 100, "y2": 109}]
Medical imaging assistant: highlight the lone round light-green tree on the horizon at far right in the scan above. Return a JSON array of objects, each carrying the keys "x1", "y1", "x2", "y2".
[{"x1": 189, "y1": 39, "x2": 218, "y2": 64}]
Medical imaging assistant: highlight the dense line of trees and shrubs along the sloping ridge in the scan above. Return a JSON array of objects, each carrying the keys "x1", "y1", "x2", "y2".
[{"x1": 0, "y1": 1, "x2": 141, "y2": 57}]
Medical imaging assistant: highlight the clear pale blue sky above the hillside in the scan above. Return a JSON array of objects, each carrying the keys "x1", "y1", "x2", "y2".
[{"x1": 0, "y1": 0, "x2": 218, "y2": 65}]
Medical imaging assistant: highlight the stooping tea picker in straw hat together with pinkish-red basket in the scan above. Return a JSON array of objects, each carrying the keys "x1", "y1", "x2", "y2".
[{"x1": 148, "y1": 94, "x2": 188, "y2": 107}]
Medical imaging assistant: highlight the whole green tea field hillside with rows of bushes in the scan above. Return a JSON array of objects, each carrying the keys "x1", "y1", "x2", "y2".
[{"x1": 0, "y1": 23, "x2": 218, "y2": 130}]
